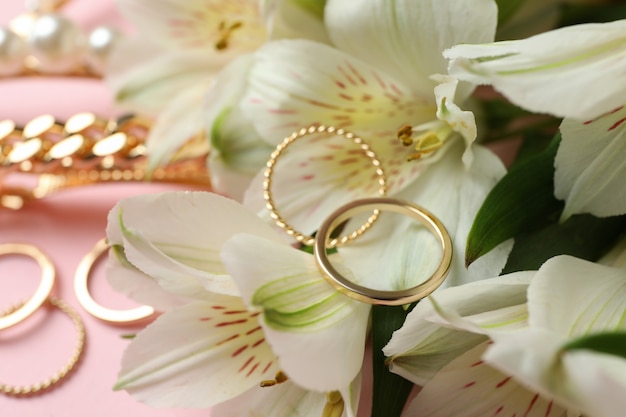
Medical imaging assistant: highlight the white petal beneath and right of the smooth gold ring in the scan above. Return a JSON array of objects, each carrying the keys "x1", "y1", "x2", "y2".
[{"x1": 340, "y1": 140, "x2": 510, "y2": 289}]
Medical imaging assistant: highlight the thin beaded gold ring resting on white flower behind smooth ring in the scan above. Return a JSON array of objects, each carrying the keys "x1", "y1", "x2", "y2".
[{"x1": 263, "y1": 125, "x2": 387, "y2": 248}]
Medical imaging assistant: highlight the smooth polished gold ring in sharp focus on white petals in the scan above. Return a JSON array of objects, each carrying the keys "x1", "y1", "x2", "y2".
[{"x1": 313, "y1": 198, "x2": 452, "y2": 306}]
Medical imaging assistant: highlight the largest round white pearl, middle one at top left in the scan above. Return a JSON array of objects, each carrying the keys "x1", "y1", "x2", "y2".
[{"x1": 28, "y1": 14, "x2": 86, "y2": 74}]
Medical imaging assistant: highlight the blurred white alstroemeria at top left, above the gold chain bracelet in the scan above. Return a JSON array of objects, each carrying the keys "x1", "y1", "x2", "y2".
[{"x1": 107, "y1": 0, "x2": 323, "y2": 171}]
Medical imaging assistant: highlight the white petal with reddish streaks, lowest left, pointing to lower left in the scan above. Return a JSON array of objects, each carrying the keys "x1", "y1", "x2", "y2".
[{"x1": 116, "y1": 297, "x2": 277, "y2": 408}]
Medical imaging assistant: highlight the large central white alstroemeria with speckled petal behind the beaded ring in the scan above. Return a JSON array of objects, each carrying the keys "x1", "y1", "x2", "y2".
[{"x1": 208, "y1": 0, "x2": 505, "y2": 289}]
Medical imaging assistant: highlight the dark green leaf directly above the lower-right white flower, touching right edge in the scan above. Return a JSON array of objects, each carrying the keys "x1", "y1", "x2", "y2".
[{"x1": 502, "y1": 214, "x2": 626, "y2": 273}]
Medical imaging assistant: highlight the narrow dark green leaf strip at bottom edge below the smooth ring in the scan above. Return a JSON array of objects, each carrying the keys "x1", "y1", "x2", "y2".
[{"x1": 371, "y1": 304, "x2": 415, "y2": 417}]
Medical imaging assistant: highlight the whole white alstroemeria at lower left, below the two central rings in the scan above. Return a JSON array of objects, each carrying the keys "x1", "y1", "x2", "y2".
[{"x1": 107, "y1": 192, "x2": 369, "y2": 417}]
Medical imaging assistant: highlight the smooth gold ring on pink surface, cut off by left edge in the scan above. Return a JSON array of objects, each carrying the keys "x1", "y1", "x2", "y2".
[{"x1": 0, "y1": 243, "x2": 54, "y2": 330}]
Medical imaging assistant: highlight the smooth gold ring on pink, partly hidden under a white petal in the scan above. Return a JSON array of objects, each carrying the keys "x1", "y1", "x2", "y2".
[{"x1": 74, "y1": 239, "x2": 154, "y2": 323}]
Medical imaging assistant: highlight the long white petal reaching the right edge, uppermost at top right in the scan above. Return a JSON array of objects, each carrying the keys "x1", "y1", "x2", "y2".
[{"x1": 444, "y1": 20, "x2": 626, "y2": 120}]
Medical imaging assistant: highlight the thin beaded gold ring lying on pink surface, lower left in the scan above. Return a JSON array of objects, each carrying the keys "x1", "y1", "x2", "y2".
[{"x1": 0, "y1": 297, "x2": 85, "y2": 396}]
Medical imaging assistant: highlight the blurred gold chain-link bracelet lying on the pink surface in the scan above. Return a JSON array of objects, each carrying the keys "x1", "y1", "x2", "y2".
[{"x1": 0, "y1": 113, "x2": 210, "y2": 209}]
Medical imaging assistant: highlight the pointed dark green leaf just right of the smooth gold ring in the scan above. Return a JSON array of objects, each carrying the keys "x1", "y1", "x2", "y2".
[{"x1": 465, "y1": 135, "x2": 563, "y2": 265}]
